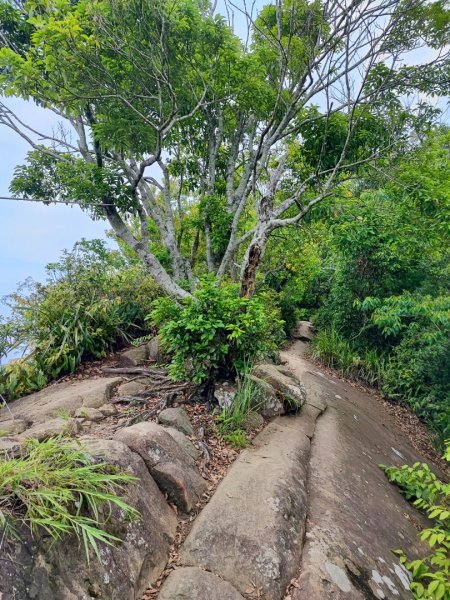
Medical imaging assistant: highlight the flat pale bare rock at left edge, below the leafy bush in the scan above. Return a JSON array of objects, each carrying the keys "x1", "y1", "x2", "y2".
[{"x1": 0, "y1": 377, "x2": 122, "y2": 430}]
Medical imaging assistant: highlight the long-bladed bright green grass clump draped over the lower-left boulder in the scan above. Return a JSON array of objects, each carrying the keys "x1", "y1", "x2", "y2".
[{"x1": 0, "y1": 436, "x2": 138, "y2": 560}]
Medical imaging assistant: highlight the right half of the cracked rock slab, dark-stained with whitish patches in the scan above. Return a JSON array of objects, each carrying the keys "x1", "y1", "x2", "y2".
[{"x1": 282, "y1": 342, "x2": 426, "y2": 600}]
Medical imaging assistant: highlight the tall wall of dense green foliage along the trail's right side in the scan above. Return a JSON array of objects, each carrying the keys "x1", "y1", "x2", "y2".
[{"x1": 304, "y1": 127, "x2": 450, "y2": 441}]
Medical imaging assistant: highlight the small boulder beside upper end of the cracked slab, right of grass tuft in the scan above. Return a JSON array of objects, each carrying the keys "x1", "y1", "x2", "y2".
[{"x1": 251, "y1": 363, "x2": 306, "y2": 412}]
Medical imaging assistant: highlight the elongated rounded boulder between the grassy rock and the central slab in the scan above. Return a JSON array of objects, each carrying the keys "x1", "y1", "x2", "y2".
[{"x1": 114, "y1": 422, "x2": 207, "y2": 512}]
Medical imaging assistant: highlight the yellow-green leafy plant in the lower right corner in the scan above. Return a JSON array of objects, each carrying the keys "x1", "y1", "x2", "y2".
[{"x1": 381, "y1": 440, "x2": 450, "y2": 600}]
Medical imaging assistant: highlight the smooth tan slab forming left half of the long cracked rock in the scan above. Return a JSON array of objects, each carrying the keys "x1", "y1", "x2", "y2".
[{"x1": 181, "y1": 417, "x2": 320, "y2": 600}]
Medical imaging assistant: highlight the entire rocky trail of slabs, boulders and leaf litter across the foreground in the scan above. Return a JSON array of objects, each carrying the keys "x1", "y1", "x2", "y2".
[{"x1": 0, "y1": 335, "x2": 444, "y2": 600}]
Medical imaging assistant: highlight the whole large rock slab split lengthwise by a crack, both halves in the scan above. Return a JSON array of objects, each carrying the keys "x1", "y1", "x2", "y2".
[{"x1": 168, "y1": 341, "x2": 432, "y2": 600}]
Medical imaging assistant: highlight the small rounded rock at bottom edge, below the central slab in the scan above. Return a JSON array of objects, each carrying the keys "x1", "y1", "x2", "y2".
[{"x1": 158, "y1": 567, "x2": 244, "y2": 600}]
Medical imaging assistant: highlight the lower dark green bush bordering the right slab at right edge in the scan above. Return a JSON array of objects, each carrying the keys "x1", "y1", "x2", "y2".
[{"x1": 361, "y1": 293, "x2": 450, "y2": 439}]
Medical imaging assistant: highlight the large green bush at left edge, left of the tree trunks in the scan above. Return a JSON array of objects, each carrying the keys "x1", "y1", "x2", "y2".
[{"x1": 0, "y1": 240, "x2": 159, "y2": 399}]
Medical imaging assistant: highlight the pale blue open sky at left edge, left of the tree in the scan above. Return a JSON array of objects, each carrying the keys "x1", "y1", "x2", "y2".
[{"x1": 0, "y1": 98, "x2": 108, "y2": 314}]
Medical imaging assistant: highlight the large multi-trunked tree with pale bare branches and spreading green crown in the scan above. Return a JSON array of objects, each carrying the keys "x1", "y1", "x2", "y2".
[{"x1": 0, "y1": 0, "x2": 450, "y2": 299}]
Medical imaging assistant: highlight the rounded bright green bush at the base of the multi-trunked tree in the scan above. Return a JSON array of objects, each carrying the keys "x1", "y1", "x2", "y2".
[{"x1": 150, "y1": 278, "x2": 284, "y2": 383}]
